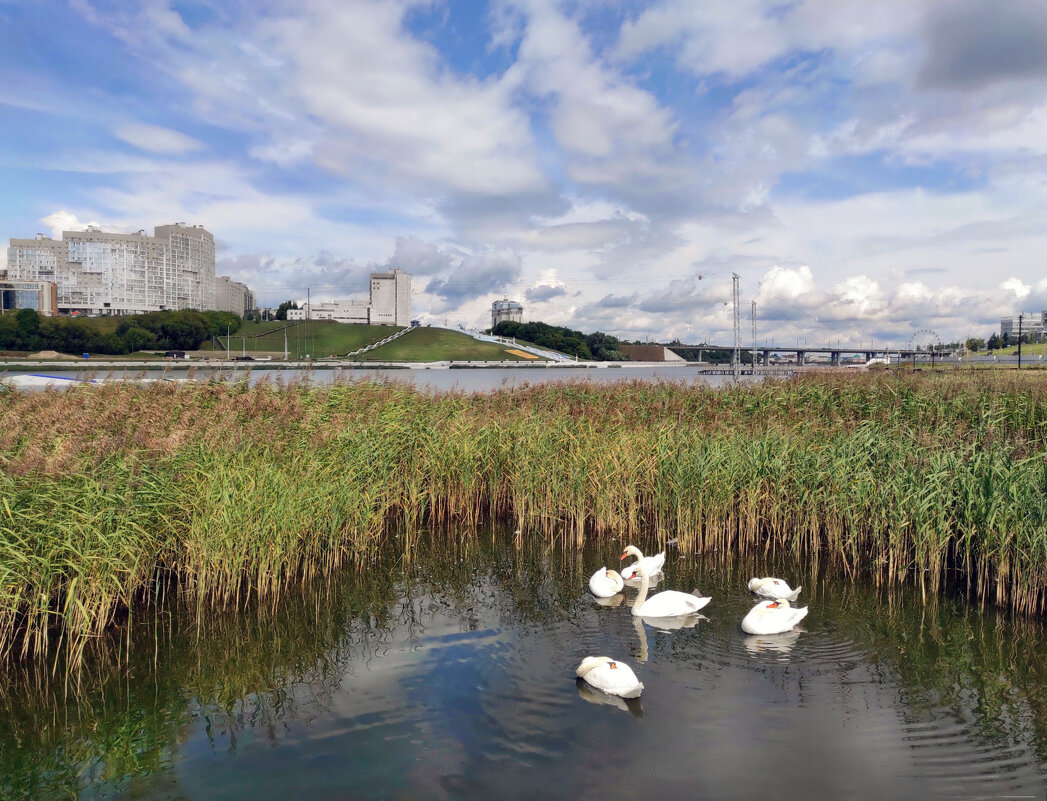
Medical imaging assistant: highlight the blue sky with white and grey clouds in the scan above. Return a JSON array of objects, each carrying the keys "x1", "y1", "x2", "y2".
[{"x1": 0, "y1": 0, "x2": 1047, "y2": 347}]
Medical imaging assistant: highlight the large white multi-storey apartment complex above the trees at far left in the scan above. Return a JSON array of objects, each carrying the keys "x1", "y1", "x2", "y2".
[{"x1": 7, "y1": 223, "x2": 216, "y2": 315}]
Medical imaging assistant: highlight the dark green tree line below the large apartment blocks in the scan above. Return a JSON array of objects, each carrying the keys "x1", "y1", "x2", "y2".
[{"x1": 0, "y1": 309, "x2": 243, "y2": 355}]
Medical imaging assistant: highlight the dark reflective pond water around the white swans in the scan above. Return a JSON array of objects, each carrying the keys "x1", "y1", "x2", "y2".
[{"x1": 0, "y1": 532, "x2": 1047, "y2": 801}]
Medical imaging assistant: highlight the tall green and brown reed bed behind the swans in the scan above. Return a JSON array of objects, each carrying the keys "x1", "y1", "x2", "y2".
[{"x1": 0, "y1": 373, "x2": 1047, "y2": 659}]
